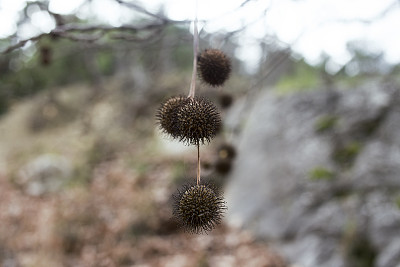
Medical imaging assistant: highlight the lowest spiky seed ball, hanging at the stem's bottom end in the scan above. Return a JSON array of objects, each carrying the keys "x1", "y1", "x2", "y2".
[{"x1": 173, "y1": 184, "x2": 227, "y2": 234}]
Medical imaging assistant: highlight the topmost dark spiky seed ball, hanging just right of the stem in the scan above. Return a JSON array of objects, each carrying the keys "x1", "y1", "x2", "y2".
[{"x1": 197, "y1": 49, "x2": 231, "y2": 86}]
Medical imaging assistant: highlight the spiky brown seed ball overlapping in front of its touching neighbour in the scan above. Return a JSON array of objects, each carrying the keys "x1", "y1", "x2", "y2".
[{"x1": 177, "y1": 97, "x2": 222, "y2": 145}]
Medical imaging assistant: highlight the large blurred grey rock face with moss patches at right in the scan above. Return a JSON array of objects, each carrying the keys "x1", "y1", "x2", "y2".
[{"x1": 225, "y1": 84, "x2": 400, "y2": 267}]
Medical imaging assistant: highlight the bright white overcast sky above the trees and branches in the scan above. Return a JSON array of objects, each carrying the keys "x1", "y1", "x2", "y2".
[{"x1": 0, "y1": 0, "x2": 400, "y2": 73}]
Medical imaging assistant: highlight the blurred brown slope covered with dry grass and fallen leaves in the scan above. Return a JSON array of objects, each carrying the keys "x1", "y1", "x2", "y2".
[{"x1": 0, "y1": 80, "x2": 287, "y2": 267}]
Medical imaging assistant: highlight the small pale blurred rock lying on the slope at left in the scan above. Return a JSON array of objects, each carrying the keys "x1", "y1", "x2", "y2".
[{"x1": 16, "y1": 154, "x2": 72, "y2": 196}]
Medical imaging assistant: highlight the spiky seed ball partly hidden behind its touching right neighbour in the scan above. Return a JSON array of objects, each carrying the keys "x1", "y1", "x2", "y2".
[{"x1": 156, "y1": 96, "x2": 187, "y2": 138}]
